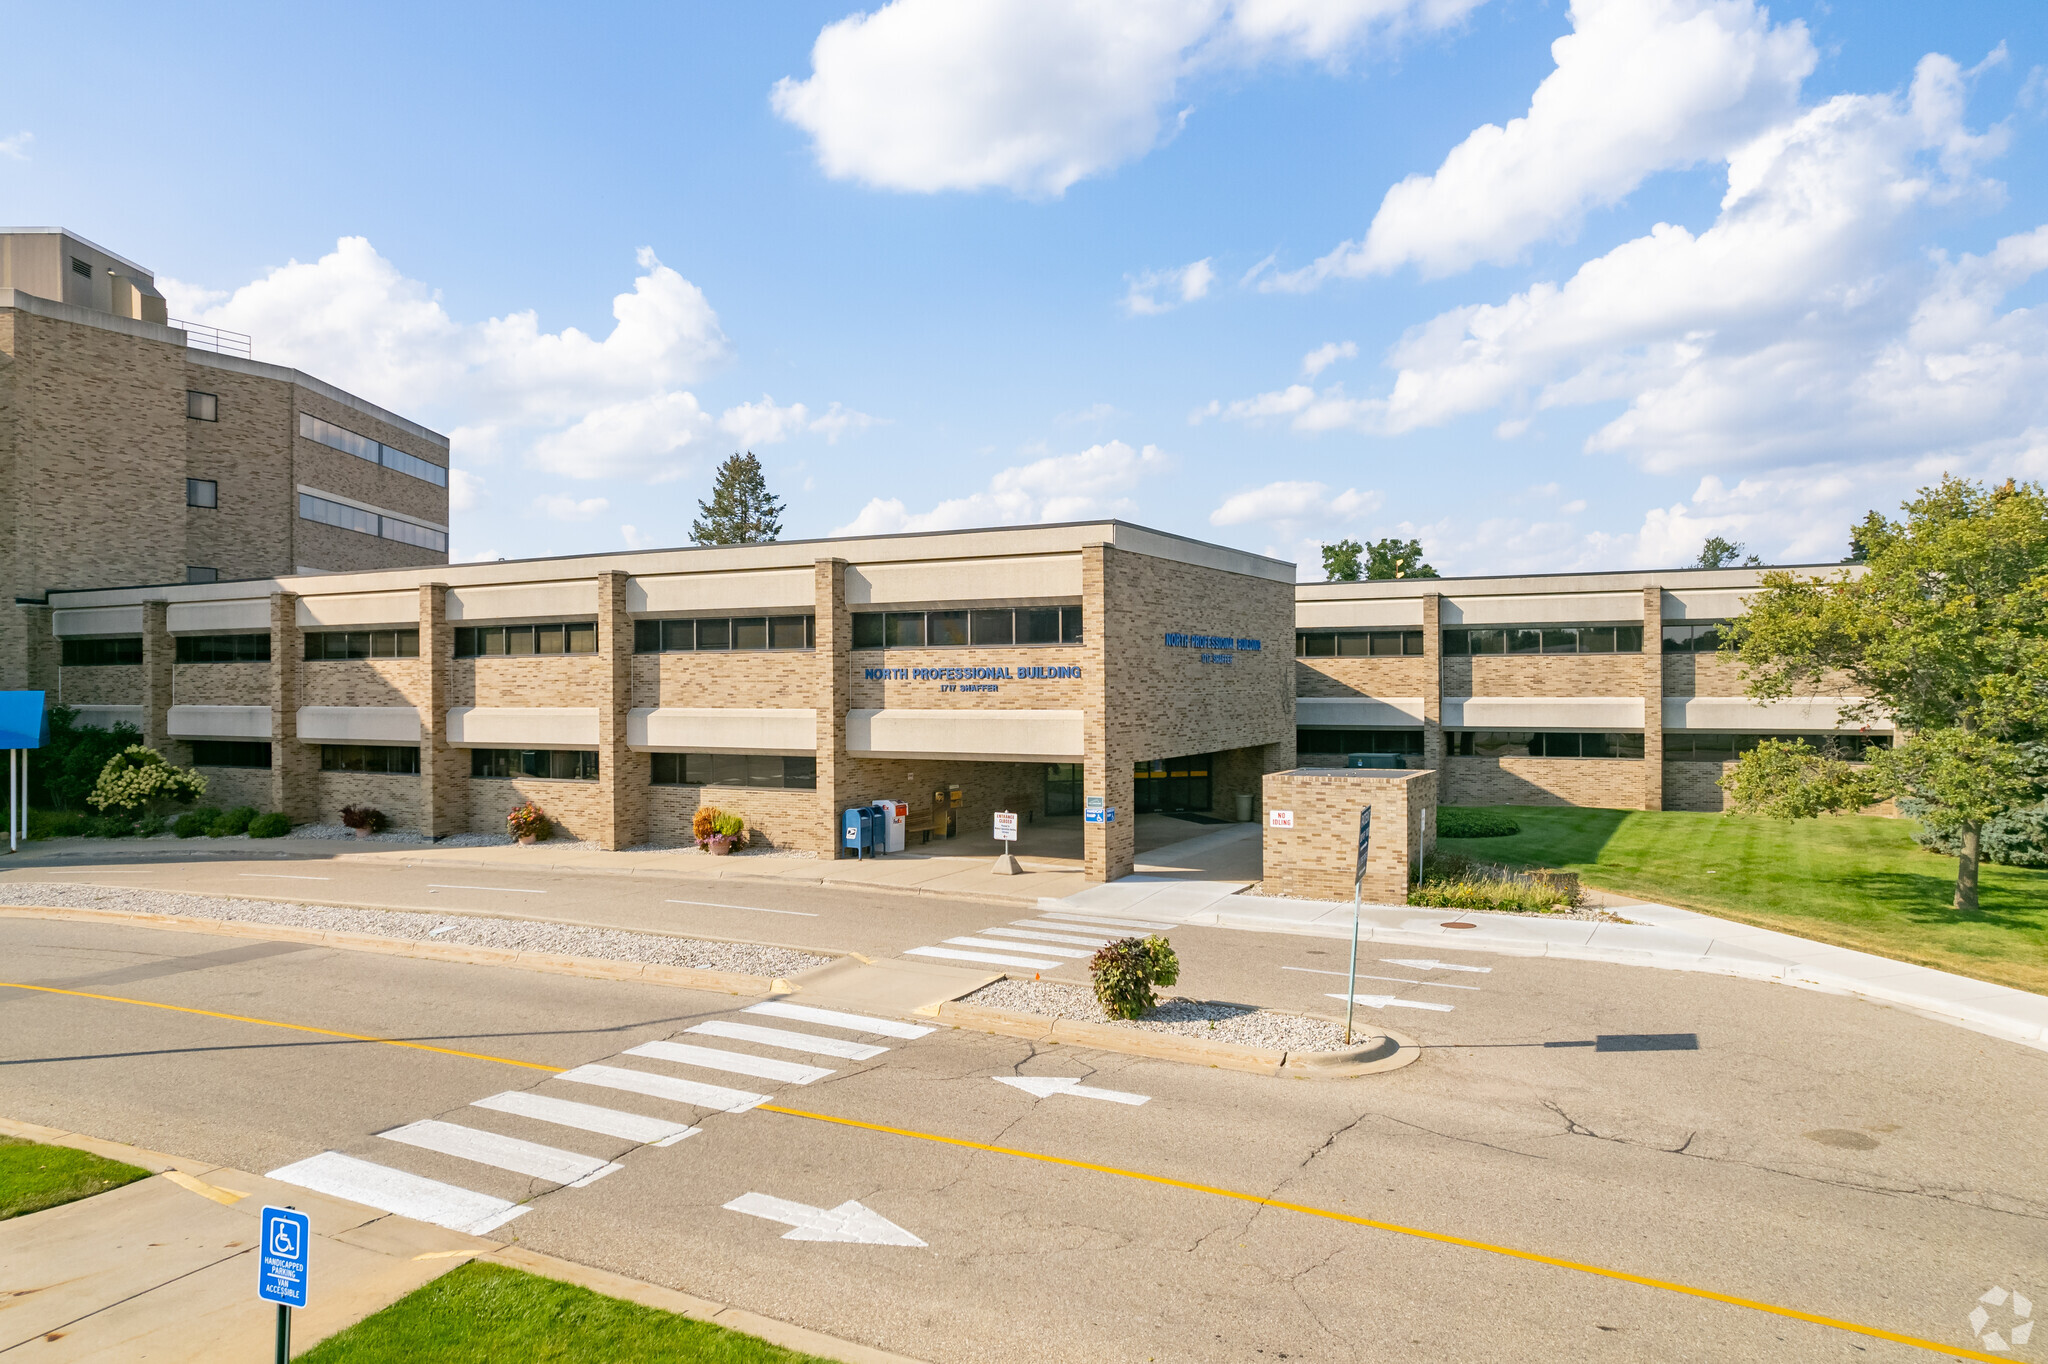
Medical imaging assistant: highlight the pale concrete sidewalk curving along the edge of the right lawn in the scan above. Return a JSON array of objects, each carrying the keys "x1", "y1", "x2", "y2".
[{"x1": 1097, "y1": 877, "x2": 2048, "y2": 1051}]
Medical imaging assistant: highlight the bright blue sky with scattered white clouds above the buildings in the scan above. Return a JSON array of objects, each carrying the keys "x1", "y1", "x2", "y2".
[{"x1": 0, "y1": 0, "x2": 2048, "y2": 578}]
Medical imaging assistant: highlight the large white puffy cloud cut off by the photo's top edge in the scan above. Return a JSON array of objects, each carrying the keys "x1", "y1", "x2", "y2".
[{"x1": 770, "y1": 0, "x2": 1481, "y2": 197}]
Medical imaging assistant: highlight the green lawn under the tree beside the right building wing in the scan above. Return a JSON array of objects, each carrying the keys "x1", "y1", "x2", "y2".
[{"x1": 1442, "y1": 805, "x2": 2048, "y2": 993}]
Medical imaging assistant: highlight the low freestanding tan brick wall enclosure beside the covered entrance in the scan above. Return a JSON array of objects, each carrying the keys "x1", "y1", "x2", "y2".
[{"x1": 1260, "y1": 768, "x2": 1438, "y2": 905}]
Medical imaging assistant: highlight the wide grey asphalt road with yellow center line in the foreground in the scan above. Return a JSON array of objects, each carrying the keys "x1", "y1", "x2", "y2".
[{"x1": 0, "y1": 897, "x2": 2048, "y2": 1364}]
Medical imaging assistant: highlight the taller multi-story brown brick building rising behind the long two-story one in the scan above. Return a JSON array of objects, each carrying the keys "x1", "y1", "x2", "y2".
[{"x1": 0, "y1": 227, "x2": 449, "y2": 688}]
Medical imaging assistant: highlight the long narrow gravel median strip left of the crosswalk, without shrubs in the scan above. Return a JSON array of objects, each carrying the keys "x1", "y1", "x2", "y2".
[{"x1": 0, "y1": 881, "x2": 834, "y2": 977}]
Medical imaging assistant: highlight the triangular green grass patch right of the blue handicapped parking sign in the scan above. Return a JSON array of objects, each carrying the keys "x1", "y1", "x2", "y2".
[{"x1": 299, "y1": 1262, "x2": 827, "y2": 1364}]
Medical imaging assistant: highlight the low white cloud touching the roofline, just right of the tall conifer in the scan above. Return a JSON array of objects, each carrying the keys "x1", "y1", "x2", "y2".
[{"x1": 834, "y1": 440, "x2": 1171, "y2": 535}]
